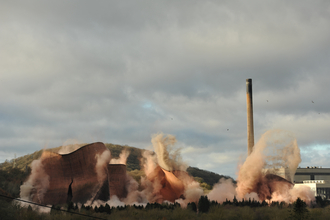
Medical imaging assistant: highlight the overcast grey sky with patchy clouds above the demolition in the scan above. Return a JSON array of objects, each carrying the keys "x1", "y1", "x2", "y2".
[{"x1": 0, "y1": 0, "x2": 330, "y2": 178}]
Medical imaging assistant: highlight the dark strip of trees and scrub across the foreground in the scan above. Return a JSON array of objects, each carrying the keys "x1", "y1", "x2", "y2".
[{"x1": 0, "y1": 196, "x2": 330, "y2": 220}]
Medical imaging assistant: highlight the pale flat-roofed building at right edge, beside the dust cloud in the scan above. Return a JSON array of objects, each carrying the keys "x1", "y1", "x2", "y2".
[{"x1": 294, "y1": 167, "x2": 330, "y2": 199}]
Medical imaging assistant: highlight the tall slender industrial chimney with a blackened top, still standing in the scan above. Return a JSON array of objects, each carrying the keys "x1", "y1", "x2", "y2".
[{"x1": 246, "y1": 79, "x2": 254, "y2": 155}]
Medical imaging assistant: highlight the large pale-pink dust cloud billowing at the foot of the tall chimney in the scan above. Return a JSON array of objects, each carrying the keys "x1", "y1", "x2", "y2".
[{"x1": 236, "y1": 130, "x2": 312, "y2": 203}]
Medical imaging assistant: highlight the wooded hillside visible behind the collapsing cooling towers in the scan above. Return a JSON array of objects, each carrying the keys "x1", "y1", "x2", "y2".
[{"x1": 0, "y1": 144, "x2": 235, "y2": 197}]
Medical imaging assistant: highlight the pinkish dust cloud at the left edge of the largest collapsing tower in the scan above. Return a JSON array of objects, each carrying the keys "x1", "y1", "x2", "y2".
[{"x1": 20, "y1": 152, "x2": 49, "y2": 203}]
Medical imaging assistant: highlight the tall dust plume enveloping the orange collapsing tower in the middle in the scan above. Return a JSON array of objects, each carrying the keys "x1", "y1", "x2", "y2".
[{"x1": 141, "y1": 133, "x2": 203, "y2": 205}]
